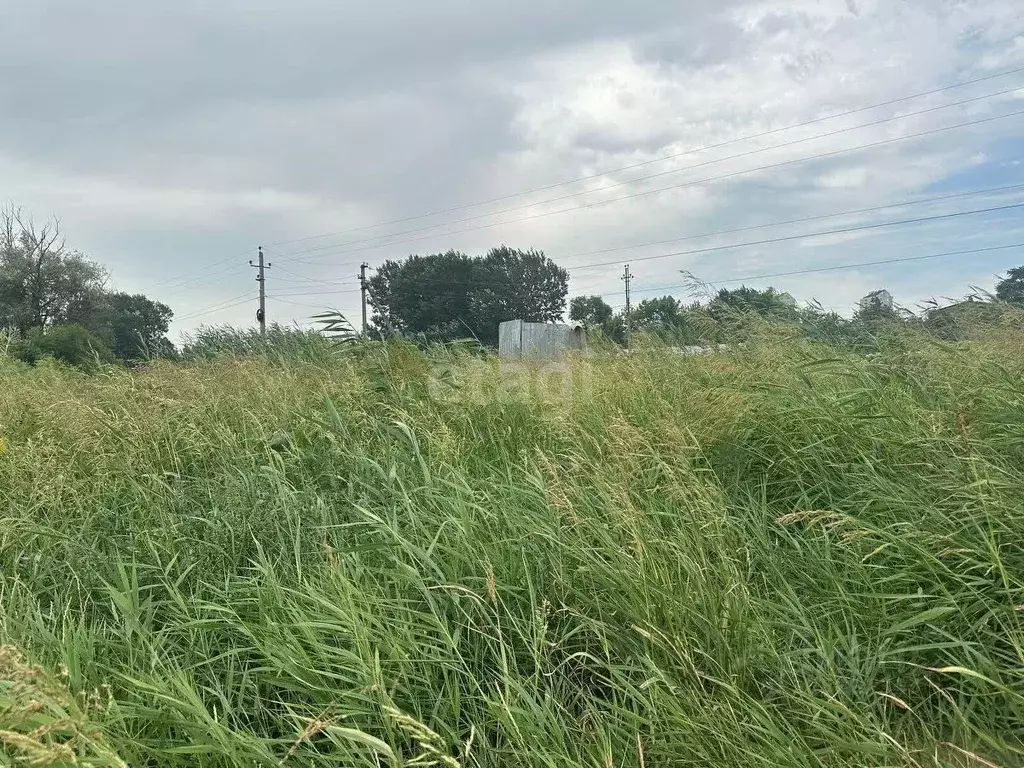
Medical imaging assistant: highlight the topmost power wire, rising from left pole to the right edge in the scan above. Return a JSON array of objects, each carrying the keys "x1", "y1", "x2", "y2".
[{"x1": 260, "y1": 67, "x2": 1024, "y2": 248}]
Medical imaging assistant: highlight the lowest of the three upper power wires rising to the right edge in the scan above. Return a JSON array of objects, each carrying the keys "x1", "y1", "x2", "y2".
[{"x1": 275, "y1": 110, "x2": 1024, "y2": 264}]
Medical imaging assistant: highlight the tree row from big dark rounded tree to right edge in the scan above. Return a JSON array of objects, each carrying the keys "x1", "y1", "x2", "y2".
[{"x1": 358, "y1": 246, "x2": 1024, "y2": 346}]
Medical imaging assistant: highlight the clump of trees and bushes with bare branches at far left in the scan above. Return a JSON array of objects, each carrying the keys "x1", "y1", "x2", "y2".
[{"x1": 0, "y1": 206, "x2": 174, "y2": 365}]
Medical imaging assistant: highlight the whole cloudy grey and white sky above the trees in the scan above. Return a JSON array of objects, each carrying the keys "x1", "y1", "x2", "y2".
[{"x1": 0, "y1": 0, "x2": 1024, "y2": 332}]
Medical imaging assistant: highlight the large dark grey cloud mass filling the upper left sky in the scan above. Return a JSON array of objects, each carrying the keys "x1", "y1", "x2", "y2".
[{"x1": 0, "y1": 0, "x2": 745, "y2": 216}]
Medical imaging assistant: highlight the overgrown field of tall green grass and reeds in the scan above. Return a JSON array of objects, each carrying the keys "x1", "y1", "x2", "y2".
[{"x1": 0, "y1": 332, "x2": 1024, "y2": 768}]
